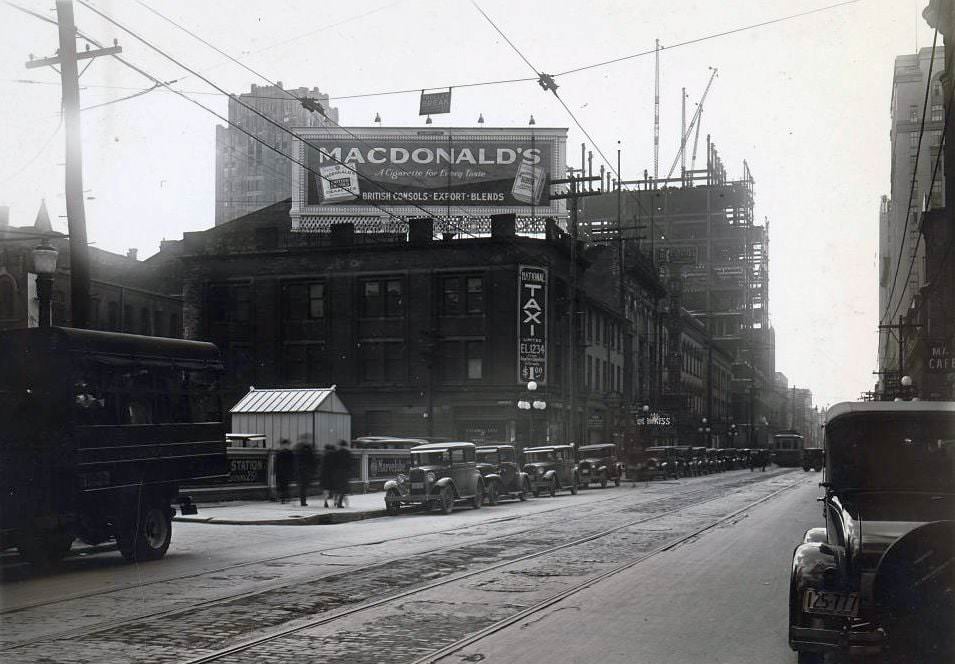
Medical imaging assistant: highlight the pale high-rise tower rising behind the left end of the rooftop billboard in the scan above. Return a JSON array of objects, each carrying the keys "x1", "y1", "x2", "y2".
[{"x1": 215, "y1": 81, "x2": 338, "y2": 226}]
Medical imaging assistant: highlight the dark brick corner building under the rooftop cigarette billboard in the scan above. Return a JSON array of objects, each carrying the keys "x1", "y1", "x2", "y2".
[{"x1": 174, "y1": 201, "x2": 659, "y2": 443}]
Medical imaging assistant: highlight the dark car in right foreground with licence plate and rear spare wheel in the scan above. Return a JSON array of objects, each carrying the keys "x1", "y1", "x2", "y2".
[{"x1": 789, "y1": 401, "x2": 955, "y2": 664}]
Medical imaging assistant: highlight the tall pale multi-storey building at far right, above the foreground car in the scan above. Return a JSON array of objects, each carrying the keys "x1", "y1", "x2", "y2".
[{"x1": 879, "y1": 47, "x2": 945, "y2": 394}]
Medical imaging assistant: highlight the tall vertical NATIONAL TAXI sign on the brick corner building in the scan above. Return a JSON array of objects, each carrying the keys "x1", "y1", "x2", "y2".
[{"x1": 517, "y1": 265, "x2": 547, "y2": 385}]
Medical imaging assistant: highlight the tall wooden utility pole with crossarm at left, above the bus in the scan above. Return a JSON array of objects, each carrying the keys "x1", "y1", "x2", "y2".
[{"x1": 26, "y1": 0, "x2": 123, "y2": 327}]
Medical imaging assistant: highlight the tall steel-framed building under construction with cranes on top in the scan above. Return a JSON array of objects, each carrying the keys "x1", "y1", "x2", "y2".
[{"x1": 579, "y1": 137, "x2": 775, "y2": 444}]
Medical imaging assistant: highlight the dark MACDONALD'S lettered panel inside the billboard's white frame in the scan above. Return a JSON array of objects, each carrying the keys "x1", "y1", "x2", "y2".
[{"x1": 304, "y1": 130, "x2": 565, "y2": 209}]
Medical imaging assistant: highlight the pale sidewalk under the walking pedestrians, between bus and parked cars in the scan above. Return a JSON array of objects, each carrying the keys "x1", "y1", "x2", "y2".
[{"x1": 173, "y1": 491, "x2": 385, "y2": 526}]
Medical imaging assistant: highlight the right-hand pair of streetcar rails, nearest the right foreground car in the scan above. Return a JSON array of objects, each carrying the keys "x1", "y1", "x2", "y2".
[{"x1": 176, "y1": 472, "x2": 800, "y2": 664}]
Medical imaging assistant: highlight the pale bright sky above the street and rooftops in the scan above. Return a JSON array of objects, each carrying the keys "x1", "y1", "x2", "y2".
[{"x1": 0, "y1": 0, "x2": 941, "y2": 405}]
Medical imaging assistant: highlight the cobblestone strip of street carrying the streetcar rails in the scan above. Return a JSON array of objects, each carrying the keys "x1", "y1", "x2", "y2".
[{"x1": 0, "y1": 471, "x2": 803, "y2": 663}]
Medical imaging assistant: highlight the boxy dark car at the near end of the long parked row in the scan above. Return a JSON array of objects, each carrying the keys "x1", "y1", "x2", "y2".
[{"x1": 385, "y1": 443, "x2": 485, "y2": 515}]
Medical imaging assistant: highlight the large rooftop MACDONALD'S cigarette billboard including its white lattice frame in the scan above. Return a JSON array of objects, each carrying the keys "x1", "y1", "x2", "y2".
[{"x1": 293, "y1": 127, "x2": 567, "y2": 226}]
